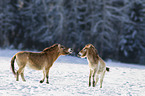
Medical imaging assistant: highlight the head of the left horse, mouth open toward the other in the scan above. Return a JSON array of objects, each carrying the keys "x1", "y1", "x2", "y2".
[{"x1": 58, "y1": 44, "x2": 73, "y2": 55}]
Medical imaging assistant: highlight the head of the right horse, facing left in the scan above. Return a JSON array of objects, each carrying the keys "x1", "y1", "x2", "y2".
[{"x1": 78, "y1": 44, "x2": 94, "y2": 58}]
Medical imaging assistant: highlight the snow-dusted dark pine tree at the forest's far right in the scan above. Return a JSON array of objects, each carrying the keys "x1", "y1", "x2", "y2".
[{"x1": 121, "y1": 2, "x2": 144, "y2": 62}]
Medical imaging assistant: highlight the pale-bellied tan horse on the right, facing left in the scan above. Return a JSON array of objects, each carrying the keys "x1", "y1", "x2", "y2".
[{"x1": 78, "y1": 44, "x2": 109, "y2": 88}]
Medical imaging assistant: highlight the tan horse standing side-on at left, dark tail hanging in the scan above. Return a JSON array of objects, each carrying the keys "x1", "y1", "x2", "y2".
[{"x1": 11, "y1": 44, "x2": 72, "y2": 84}]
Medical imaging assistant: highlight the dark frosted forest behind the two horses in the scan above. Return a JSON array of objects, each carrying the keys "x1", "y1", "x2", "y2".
[{"x1": 0, "y1": 0, "x2": 145, "y2": 65}]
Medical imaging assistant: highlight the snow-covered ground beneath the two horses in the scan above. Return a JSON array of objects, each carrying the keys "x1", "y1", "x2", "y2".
[{"x1": 0, "y1": 49, "x2": 145, "y2": 96}]
